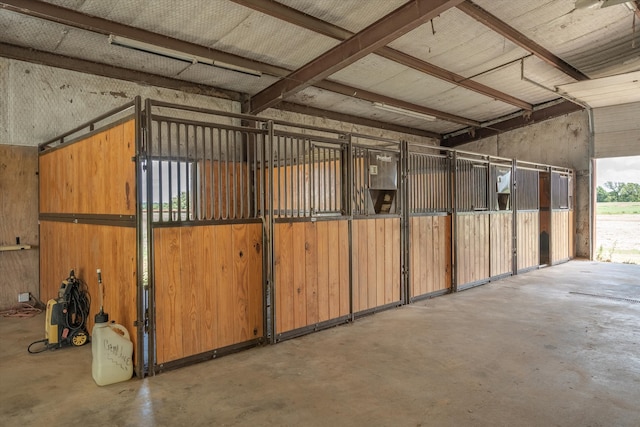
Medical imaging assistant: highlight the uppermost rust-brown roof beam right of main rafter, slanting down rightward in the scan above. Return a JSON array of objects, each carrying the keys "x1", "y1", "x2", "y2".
[{"x1": 457, "y1": 0, "x2": 589, "y2": 81}]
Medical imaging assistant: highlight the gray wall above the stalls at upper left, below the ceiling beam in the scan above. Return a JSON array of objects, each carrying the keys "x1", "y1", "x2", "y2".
[{"x1": 0, "y1": 58, "x2": 240, "y2": 149}]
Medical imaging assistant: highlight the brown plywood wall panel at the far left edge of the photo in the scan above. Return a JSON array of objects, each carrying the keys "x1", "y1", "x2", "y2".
[{"x1": 0, "y1": 144, "x2": 39, "y2": 310}]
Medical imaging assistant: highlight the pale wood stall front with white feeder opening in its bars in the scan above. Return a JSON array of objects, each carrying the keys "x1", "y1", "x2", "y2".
[{"x1": 454, "y1": 152, "x2": 514, "y2": 290}]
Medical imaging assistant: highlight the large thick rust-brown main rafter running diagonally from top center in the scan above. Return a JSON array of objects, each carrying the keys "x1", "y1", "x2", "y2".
[{"x1": 250, "y1": 0, "x2": 462, "y2": 113}]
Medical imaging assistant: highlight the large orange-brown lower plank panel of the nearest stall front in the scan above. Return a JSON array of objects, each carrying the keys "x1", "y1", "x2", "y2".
[{"x1": 153, "y1": 223, "x2": 264, "y2": 364}]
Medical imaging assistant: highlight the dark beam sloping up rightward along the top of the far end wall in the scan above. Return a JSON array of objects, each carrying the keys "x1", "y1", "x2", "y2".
[{"x1": 440, "y1": 101, "x2": 583, "y2": 148}]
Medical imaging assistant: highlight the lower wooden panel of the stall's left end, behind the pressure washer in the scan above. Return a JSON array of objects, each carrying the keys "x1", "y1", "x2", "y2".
[{"x1": 40, "y1": 221, "x2": 137, "y2": 361}]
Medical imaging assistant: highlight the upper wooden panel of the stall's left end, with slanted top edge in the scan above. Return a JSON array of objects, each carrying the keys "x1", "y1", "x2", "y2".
[{"x1": 40, "y1": 120, "x2": 136, "y2": 215}]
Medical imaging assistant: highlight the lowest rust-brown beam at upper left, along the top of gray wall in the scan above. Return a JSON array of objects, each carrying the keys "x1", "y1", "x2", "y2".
[{"x1": 0, "y1": 43, "x2": 243, "y2": 102}]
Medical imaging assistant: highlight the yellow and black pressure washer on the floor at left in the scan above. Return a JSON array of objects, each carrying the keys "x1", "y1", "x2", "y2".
[{"x1": 27, "y1": 270, "x2": 91, "y2": 353}]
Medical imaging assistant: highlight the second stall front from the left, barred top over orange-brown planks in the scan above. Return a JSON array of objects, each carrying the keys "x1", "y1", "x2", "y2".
[{"x1": 265, "y1": 123, "x2": 351, "y2": 342}]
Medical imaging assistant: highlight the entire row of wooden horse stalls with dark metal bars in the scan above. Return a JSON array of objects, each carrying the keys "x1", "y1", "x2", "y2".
[{"x1": 39, "y1": 98, "x2": 574, "y2": 377}]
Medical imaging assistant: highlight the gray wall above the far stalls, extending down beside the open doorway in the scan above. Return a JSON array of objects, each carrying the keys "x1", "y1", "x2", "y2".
[{"x1": 456, "y1": 111, "x2": 591, "y2": 258}]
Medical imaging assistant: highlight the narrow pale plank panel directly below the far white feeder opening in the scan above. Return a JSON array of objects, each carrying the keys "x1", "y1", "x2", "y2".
[{"x1": 489, "y1": 211, "x2": 513, "y2": 277}]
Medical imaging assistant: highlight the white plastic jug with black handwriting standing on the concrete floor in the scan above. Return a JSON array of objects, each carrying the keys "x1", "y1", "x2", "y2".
[{"x1": 91, "y1": 312, "x2": 133, "y2": 386}]
